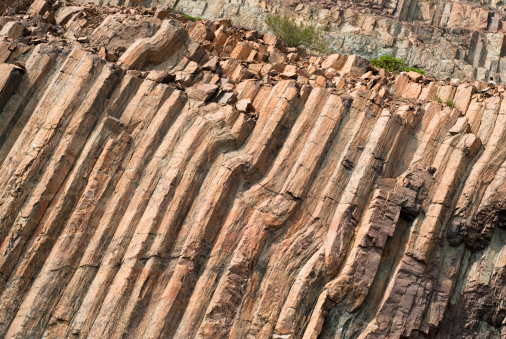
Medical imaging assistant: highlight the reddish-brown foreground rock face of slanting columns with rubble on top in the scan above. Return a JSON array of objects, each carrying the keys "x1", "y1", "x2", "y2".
[{"x1": 0, "y1": 1, "x2": 506, "y2": 339}]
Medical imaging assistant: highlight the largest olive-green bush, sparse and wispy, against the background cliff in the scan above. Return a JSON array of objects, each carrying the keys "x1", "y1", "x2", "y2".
[{"x1": 265, "y1": 15, "x2": 328, "y2": 53}]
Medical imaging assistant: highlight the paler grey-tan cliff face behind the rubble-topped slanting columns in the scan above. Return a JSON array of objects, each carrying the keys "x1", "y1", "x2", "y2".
[{"x1": 72, "y1": 0, "x2": 506, "y2": 82}]
